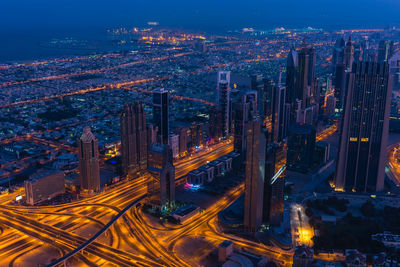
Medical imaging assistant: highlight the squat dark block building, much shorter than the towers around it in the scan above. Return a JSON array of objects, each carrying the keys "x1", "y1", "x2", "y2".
[{"x1": 286, "y1": 123, "x2": 316, "y2": 173}]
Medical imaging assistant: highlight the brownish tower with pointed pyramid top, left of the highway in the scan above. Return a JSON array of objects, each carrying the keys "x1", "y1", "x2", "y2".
[{"x1": 78, "y1": 126, "x2": 100, "y2": 193}]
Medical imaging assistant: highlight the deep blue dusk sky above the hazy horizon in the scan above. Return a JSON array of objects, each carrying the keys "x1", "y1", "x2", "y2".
[{"x1": 0, "y1": 0, "x2": 400, "y2": 32}]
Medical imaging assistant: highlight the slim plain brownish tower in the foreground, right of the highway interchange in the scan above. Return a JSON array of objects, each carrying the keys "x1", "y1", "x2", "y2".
[{"x1": 244, "y1": 120, "x2": 266, "y2": 232}]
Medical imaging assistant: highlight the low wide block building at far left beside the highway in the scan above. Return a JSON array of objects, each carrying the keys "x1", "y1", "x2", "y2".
[{"x1": 24, "y1": 170, "x2": 65, "y2": 205}]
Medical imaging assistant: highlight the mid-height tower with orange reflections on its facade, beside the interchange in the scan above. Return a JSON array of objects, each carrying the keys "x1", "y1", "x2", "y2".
[{"x1": 147, "y1": 143, "x2": 175, "y2": 207}]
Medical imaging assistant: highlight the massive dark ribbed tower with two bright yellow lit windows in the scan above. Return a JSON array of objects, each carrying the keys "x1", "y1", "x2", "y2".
[{"x1": 335, "y1": 62, "x2": 392, "y2": 192}]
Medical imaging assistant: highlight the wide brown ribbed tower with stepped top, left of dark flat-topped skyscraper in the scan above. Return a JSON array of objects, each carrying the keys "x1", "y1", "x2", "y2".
[{"x1": 120, "y1": 102, "x2": 147, "y2": 176}]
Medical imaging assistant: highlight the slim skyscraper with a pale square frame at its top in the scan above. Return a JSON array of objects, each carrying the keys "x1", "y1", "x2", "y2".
[{"x1": 217, "y1": 71, "x2": 231, "y2": 137}]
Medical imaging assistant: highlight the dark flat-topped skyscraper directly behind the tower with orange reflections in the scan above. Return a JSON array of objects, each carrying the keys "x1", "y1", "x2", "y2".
[{"x1": 153, "y1": 88, "x2": 169, "y2": 145}]
